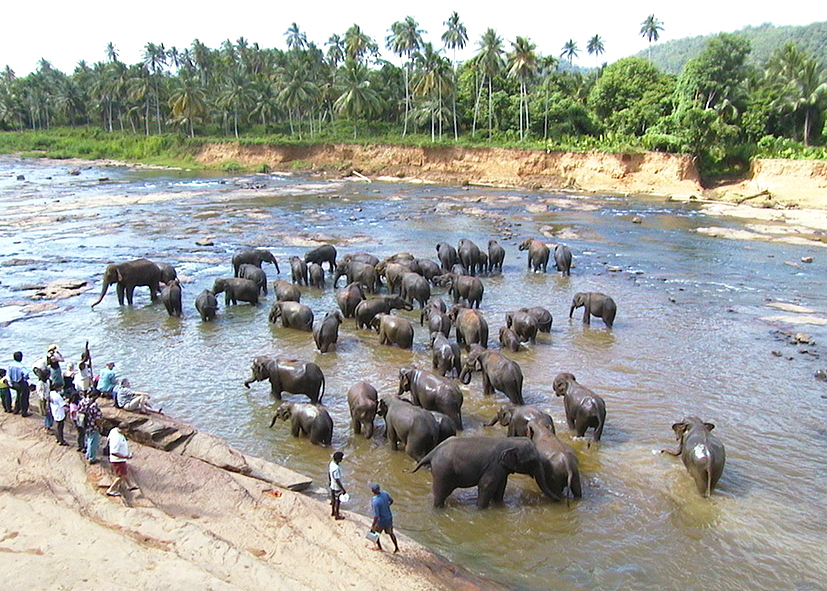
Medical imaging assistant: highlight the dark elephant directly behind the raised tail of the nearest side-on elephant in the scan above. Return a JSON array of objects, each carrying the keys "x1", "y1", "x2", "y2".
[{"x1": 376, "y1": 396, "x2": 439, "y2": 461}]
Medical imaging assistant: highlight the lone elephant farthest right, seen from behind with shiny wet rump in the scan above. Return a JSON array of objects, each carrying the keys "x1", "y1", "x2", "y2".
[{"x1": 662, "y1": 416, "x2": 726, "y2": 498}]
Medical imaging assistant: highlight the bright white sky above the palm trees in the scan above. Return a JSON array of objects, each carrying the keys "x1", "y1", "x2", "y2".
[{"x1": 0, "y1": 0, "x2": 827, "y2": 76}]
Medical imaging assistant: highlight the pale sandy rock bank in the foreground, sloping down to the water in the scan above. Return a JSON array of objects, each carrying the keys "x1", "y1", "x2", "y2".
[{"x1": 0, "y1": 413, "x2": 501, "y2": 591}]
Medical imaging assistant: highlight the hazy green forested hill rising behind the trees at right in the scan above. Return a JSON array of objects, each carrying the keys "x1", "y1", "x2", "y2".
[{"x1": 637, "y1": 22, "x2": 827, "y2": 74}]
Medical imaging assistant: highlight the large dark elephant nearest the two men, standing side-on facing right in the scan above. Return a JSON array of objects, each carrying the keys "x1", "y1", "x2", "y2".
[{"x1": 411, "y1": 437, "x2": 560, "y2": 509}]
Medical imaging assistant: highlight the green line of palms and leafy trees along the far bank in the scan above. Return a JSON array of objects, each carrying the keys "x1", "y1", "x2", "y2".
[{"x1": 0, "y1": 12, "x2": 827, "y2": 170}]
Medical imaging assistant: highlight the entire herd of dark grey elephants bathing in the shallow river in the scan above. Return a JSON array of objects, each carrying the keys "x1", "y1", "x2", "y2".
[{"x1": 92, "y1": 238, "x2": 724, "y2": 508}]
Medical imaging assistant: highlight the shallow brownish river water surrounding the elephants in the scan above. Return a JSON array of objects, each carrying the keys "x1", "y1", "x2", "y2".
[{"x1": 0, "y1": 159, "x2": 827, "y2": 590}]
